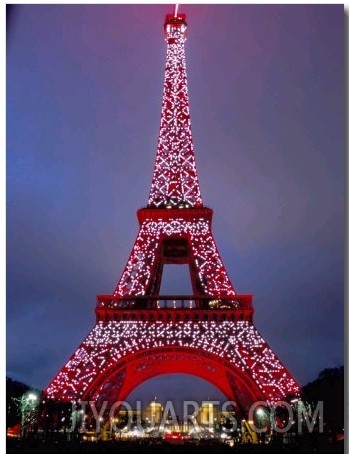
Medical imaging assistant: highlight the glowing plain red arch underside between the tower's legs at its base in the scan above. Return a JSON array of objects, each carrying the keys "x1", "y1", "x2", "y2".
[{"x1": 88, "y1": 347, "x2": 263, "y2": 409}]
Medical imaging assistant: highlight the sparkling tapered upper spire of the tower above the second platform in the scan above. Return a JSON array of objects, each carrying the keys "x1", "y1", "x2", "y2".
[{"x1": 148, "y1": 11, "x2": 202, "y2": 208}]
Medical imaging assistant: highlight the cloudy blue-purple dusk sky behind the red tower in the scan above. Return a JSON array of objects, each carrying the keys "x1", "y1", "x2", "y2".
[{"x1": 6, "y1": 4, "x2": 344, "y2": 408}]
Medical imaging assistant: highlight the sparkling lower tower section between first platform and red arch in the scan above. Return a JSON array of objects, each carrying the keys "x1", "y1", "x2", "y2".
[{"x1": 46, "y1": 321, "x2": 299, "y2": 403}]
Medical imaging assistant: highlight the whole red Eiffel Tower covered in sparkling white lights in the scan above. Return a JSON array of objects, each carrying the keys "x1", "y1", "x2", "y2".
[{"x1": 45, "y1": 11, "x2": 299, "y2": 414}]
